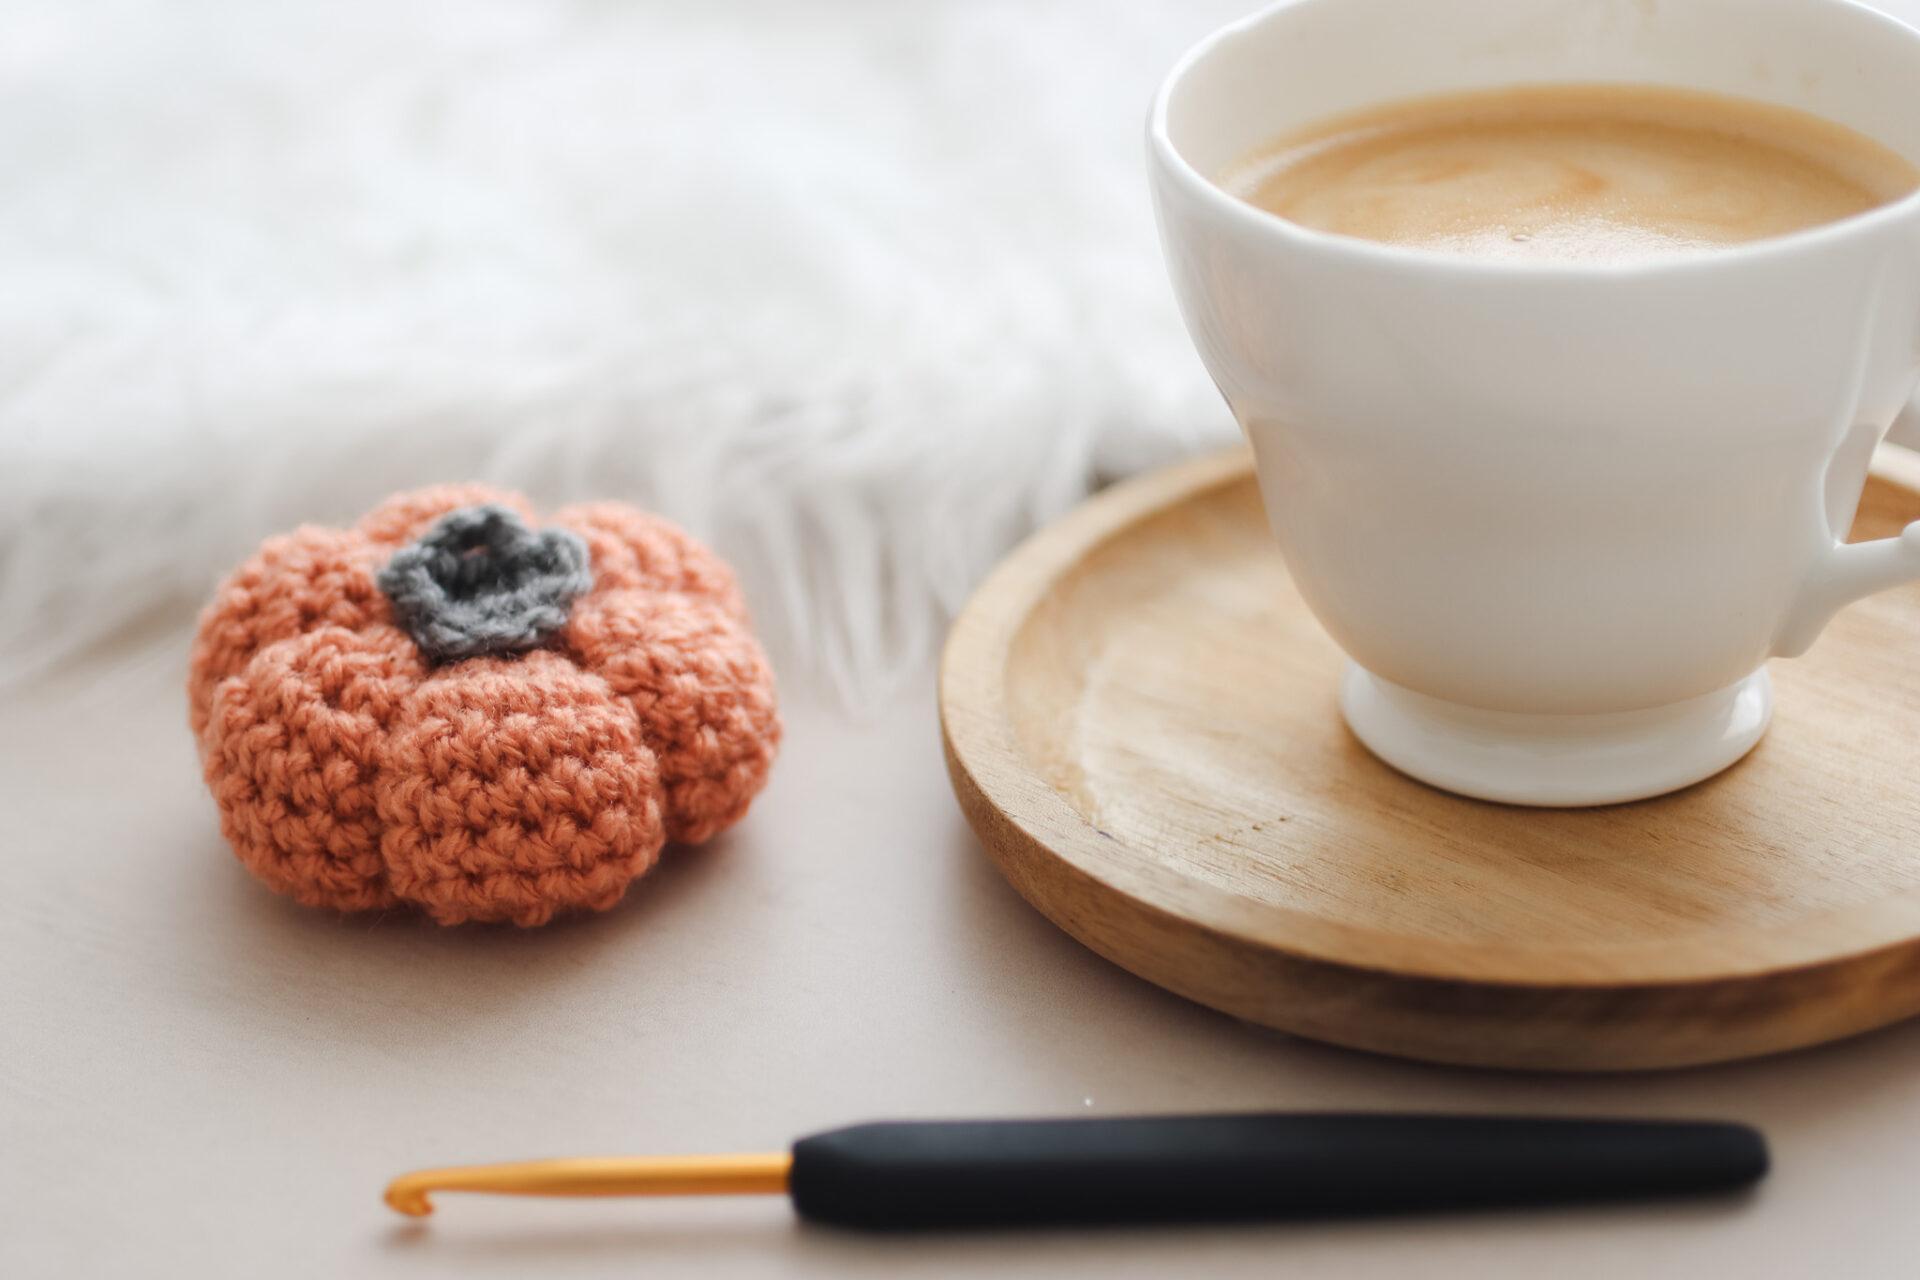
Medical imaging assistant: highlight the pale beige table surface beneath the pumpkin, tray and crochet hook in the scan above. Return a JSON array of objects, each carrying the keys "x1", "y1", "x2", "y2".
[{"x1": 0, "y1": 622, "x2": 1920, "y2": 1278}]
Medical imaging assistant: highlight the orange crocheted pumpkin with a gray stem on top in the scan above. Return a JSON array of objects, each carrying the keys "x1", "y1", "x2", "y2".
[{"x1": 188, "y1": 486, "x2": 780, "y2": 925}]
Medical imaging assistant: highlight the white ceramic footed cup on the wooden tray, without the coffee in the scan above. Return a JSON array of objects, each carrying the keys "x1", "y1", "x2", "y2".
[{"x1": 1148, "y1": 0, "x2": 1920, "y2": 804}]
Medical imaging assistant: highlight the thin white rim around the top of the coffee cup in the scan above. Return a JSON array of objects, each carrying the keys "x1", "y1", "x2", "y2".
[{"x1": 1146, "y1": 0, "x2": 1920, "y2": 280}]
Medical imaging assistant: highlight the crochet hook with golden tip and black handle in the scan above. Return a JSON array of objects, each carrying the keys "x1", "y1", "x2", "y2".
[{"x1": 386, "y1": 1113, "x2": 1766, "y2": 1230}]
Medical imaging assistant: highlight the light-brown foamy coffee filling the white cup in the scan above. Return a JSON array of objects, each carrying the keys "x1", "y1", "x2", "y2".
[{"x1": 1221, "y1": 84, "x2": 1920, "y2": 263}]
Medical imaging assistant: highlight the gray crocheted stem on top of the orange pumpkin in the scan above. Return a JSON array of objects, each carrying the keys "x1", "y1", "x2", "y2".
[{"x1": 378, "y1": 503, "x2": 593, "y2": 662}]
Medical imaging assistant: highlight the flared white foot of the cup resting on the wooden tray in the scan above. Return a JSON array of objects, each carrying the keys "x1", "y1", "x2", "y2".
[{"x1": 1340, "y1": 662, "x2": 1774, "y2": 808}]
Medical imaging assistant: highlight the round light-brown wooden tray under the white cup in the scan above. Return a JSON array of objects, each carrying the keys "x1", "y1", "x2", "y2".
[{"x1": 941, "y1": 449, "x2": 1920, "y2": 1071}]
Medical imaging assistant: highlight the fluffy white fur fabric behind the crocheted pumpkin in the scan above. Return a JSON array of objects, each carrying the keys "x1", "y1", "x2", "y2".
[{"x1": 0, "y1": 0, "x2": 1246, "y2": 693}]
